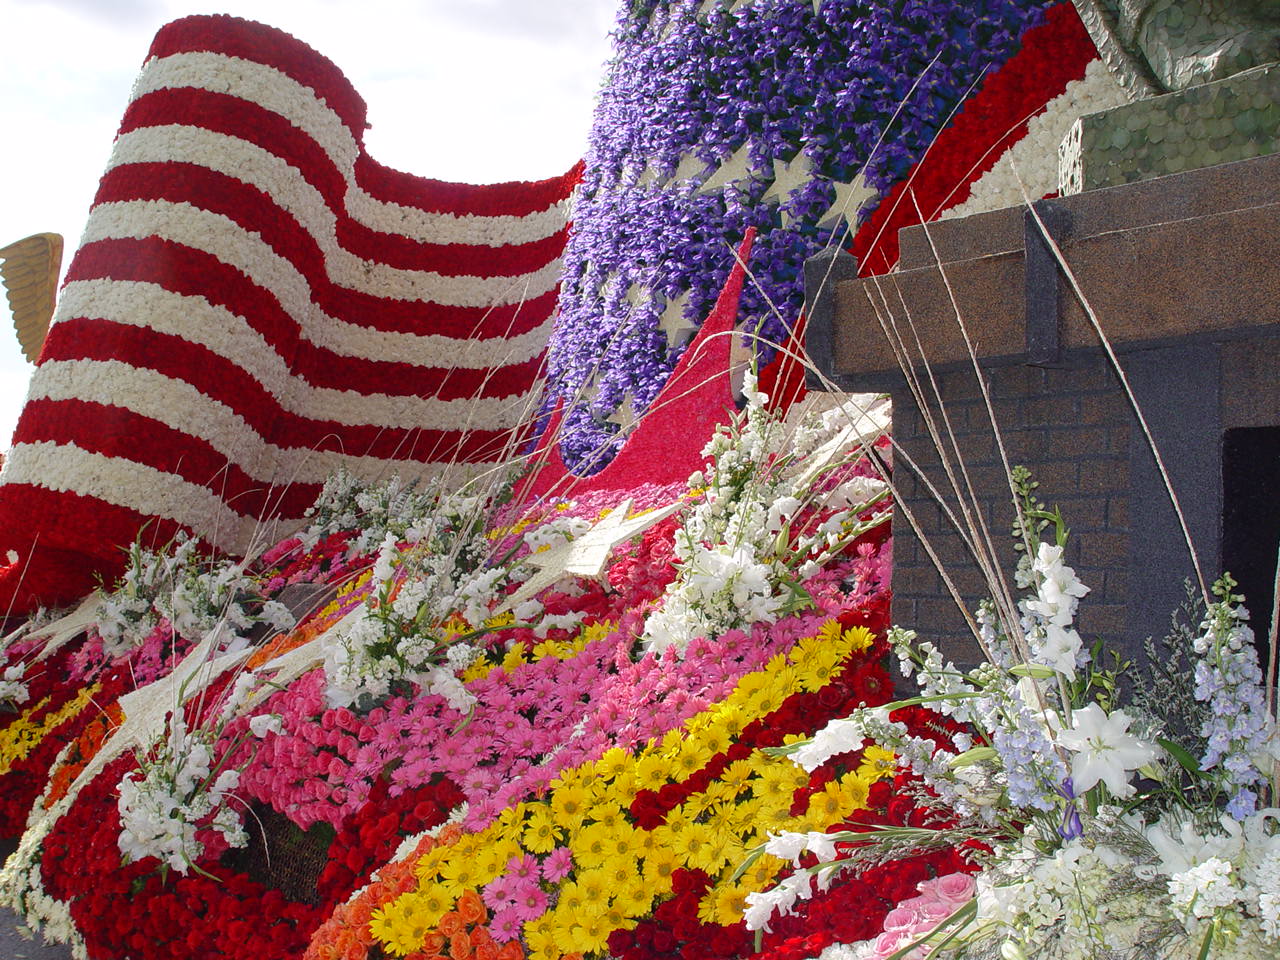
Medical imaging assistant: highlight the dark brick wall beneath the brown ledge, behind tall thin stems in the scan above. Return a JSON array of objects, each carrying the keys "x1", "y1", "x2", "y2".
[{"x1": 892, "y1": 355, "x2": 1130, "y2": 660}]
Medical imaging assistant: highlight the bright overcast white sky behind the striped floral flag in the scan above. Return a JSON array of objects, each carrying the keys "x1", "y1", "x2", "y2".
[{"x1": 0, "y1": 0, "x2": 620, "y2": 449}]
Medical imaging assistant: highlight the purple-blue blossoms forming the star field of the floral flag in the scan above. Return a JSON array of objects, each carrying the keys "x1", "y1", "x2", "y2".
[{"x1": 549, "y1": 0, "x2": 1051, "y2": 472}]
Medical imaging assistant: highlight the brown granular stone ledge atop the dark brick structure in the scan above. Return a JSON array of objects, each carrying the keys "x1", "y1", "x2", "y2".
[{"x1": 809, "y1": 156, "x2": 1280, "y2": 385}]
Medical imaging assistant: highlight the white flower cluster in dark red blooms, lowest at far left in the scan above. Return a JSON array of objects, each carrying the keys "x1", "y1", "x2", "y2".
[{"x1": 116, "y1": 714, "x2": 248, "y2": 873}]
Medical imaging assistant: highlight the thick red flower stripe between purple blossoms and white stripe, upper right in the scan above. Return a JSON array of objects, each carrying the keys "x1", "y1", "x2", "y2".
[{"x1": 852, "y1": 3, "x2": 1098, "y2": 276}]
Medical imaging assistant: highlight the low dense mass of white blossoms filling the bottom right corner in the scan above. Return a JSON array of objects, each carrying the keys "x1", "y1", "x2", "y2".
[{"x1": 975, "y1": 808, "x2": 1280, "y2": 960}]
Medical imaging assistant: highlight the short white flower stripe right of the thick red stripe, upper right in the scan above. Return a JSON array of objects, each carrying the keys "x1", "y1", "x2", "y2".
[{"x1": 940, "y1": 60, "x2": 1129, "y2": 220}]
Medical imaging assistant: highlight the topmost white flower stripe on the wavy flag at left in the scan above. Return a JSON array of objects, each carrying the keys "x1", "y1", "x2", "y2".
[{"x1": 133, "y1": 52, "x2": 570, "y2": 247}]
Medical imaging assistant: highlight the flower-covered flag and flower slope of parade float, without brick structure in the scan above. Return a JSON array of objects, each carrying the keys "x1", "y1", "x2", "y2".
[{"x1": 0, "y1": 0, "x2": 1280, "y2": 960}]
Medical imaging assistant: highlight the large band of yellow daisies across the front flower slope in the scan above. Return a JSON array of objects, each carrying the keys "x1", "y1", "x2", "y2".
[{"x1": 369, "y1": 621, "x2": 887, "y2": 960}]
